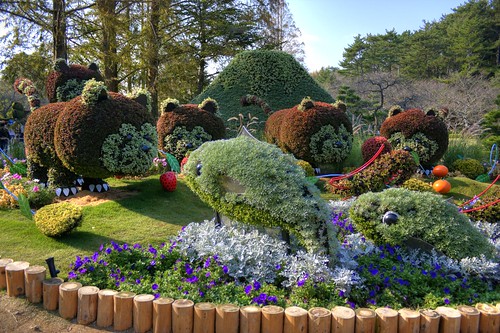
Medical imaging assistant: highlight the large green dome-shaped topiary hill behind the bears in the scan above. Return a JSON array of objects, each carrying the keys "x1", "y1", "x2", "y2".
[{"x1": 192, "y1": 50, "x2": 334, "y2": 135}]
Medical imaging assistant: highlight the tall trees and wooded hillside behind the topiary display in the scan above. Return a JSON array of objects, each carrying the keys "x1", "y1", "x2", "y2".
[{"x1": 0, "y1": 0, "x2": 500, "y2": 146}]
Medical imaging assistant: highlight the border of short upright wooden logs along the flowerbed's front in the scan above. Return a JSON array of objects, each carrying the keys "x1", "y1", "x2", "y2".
[{"x1": 0, "y1": 259, "x2": 500, "y2": 333}]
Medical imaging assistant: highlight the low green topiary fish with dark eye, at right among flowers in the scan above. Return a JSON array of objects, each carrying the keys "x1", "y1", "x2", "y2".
[{"x1": 349, "y1": 188, "x2": 494, "y2": 259}]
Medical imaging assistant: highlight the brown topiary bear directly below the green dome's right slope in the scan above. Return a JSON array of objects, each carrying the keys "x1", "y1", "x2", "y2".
[{"x1": 264, "y1": 98, "x2": 353, "y2": 168}]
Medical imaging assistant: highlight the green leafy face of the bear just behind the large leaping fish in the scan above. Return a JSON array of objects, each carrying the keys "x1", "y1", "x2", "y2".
[{"x1": 164, "y1": 126, "x2": 212, "y2": 160}]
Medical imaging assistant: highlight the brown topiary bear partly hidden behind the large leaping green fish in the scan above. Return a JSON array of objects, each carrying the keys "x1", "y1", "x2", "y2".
[{"x1": 156, "y1": 98, "x2": 226, "y2": 161}]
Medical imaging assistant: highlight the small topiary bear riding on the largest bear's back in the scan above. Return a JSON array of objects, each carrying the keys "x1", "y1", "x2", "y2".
[{"x1": 45, "y1": 59, "x2": 104, "y2": 103}]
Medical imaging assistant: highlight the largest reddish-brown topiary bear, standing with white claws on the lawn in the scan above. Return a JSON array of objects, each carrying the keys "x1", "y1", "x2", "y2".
[{"x1": 17, "y1": 79, "x2": 157, "y2": 195}]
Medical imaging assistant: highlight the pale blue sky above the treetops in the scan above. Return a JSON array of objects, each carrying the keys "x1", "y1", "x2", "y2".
[{"x1": 288, "y1": 0, "x2": 467, "y2": 72}]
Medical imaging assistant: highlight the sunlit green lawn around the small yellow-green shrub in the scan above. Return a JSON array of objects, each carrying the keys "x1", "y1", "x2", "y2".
[{"x1": 0, "y1": 176, "x2": 214, "y2": 277}]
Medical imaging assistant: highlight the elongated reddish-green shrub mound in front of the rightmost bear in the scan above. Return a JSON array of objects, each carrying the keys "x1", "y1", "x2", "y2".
[{"x1": 329, "y1": 150, "x2": 417, "y2": 197}]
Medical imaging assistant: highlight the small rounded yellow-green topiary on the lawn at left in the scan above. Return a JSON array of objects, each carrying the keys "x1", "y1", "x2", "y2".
[{"x1": 34, "y1": 202, "x2": 82, "y2": 237}]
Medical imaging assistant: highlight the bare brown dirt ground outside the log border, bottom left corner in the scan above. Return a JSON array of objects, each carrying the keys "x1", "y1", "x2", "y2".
[{"x1": 0, "y1": 290, "x2": 134, "y2": 333}]
